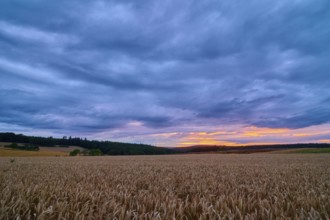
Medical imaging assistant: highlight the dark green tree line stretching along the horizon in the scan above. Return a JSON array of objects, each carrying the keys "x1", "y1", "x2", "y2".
[{"x1": 0, "y1": 132, "x2": 330, "y2": 156}]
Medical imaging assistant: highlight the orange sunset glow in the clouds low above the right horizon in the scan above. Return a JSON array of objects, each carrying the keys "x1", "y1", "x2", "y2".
[{"x1": 175, "y1": 125, "x2": 330, "y2": 147}]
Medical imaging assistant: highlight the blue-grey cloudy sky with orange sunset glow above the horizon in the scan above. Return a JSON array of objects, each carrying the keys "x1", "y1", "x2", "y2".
[{"x1": 0, "y1": 0, "x2": 330, "y2": 147}]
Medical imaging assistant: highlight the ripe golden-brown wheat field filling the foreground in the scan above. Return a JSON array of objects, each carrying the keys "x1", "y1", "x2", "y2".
[{"x1": 0, "y1": 154, "x2": 330, "y2": 219}]
